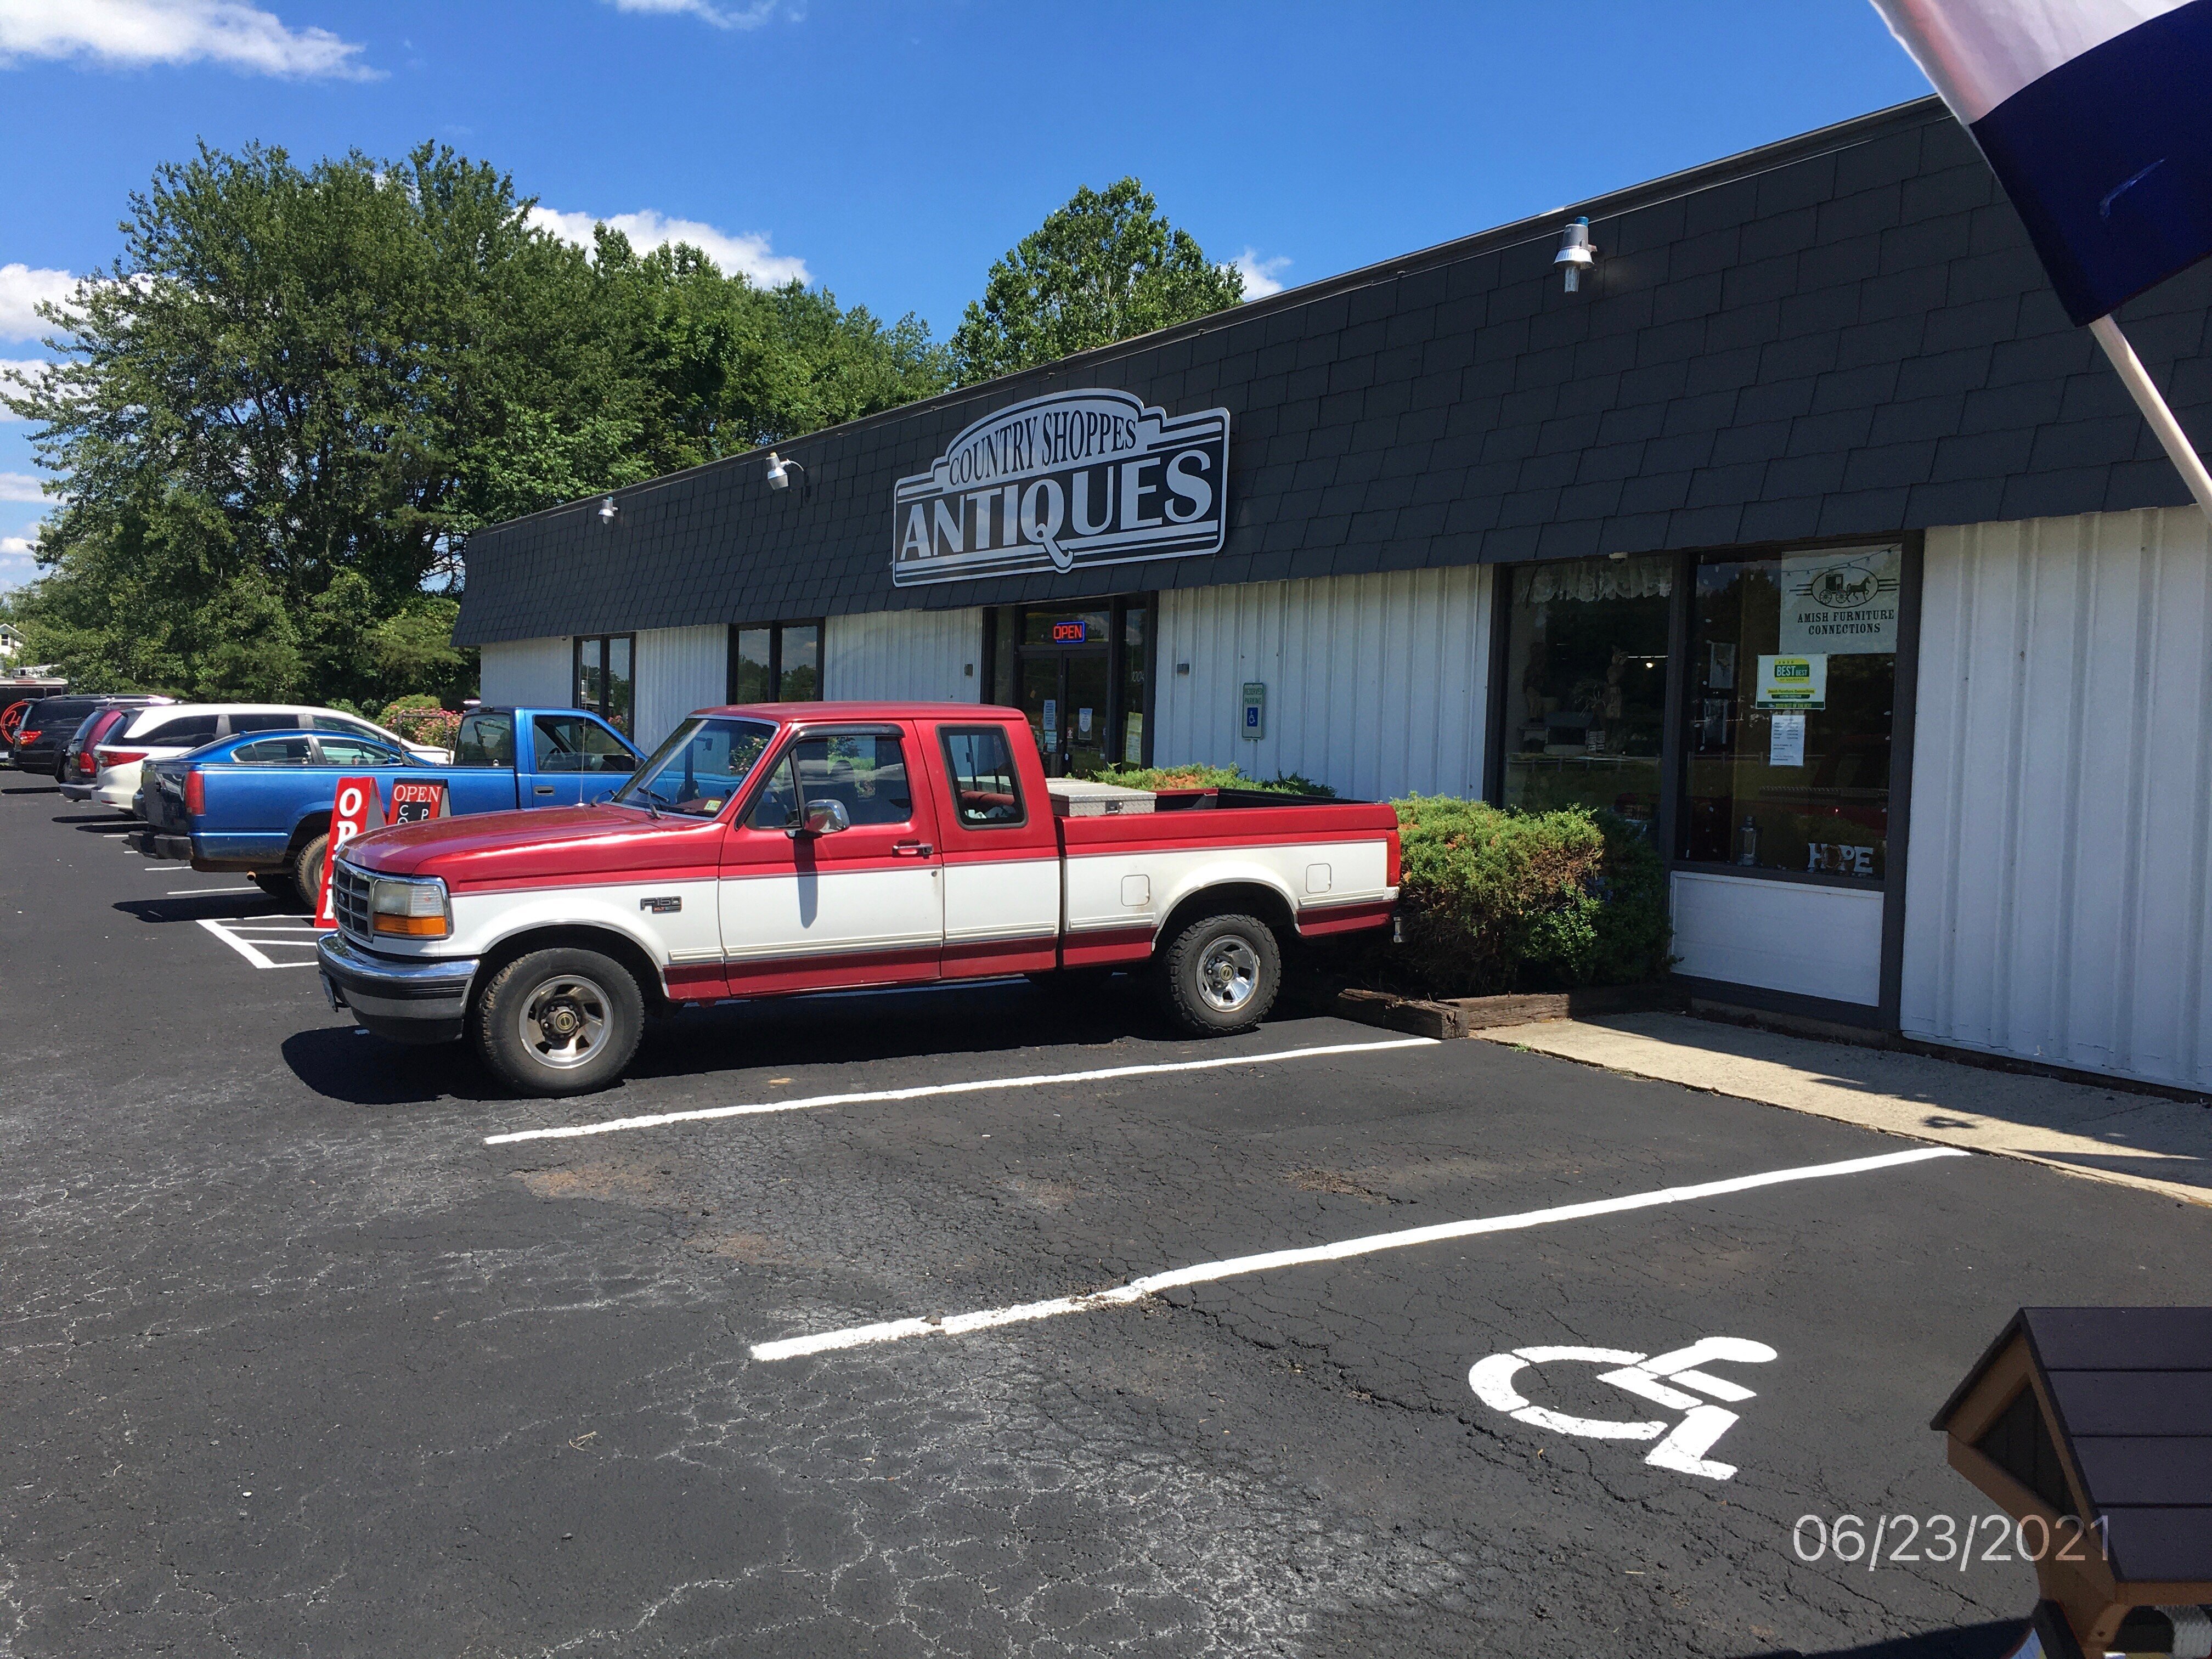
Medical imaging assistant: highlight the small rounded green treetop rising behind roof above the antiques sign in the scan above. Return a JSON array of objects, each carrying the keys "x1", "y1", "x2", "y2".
[{"x1": 951, "y1": 179, "x2": 1243, "y2": 385}]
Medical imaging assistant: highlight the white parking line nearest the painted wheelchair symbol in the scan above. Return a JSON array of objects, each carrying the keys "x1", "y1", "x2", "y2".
[{"x1": 752, "y1": 1146, "x2": 1971, "y2": 1361}]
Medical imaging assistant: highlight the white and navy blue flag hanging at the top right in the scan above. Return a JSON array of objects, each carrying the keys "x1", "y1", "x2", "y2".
[{"x1": 1874, "y1": 0, "x2": 2212, "y2": 323}]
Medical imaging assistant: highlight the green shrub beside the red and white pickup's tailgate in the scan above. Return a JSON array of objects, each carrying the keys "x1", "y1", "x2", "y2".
[{"x1": 1369, "y1": 797, "x2": 1668, "y2": 995}]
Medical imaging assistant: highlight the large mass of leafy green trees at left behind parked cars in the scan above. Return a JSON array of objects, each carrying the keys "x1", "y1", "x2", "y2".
[{"x1": 0, "y1": 133, "x2": 951, "y2": 703}]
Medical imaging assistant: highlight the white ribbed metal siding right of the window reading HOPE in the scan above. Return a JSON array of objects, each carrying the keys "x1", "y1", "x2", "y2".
[{"x1": 1903, "y1": 509, "x2": 2212, "y2": 1086}]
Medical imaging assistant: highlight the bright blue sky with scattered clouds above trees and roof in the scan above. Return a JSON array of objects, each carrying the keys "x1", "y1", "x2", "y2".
[{"x1": 0, "y1": 0, "x2": 1927, "y2": 586}]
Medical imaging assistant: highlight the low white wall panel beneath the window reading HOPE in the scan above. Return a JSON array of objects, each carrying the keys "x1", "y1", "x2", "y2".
[{"x1": 1670, "y1": 870, "x2": 1882, "y2": 1007}]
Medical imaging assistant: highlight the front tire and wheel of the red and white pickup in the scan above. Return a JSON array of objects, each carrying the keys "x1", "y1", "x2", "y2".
[{"x1": 469, "y1": 949, "x2": 646, "y2": 1095}]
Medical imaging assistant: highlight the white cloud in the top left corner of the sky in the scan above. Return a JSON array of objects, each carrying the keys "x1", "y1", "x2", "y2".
[{"x1": 0, "y1": 0, "x2": 374, "y2": 80}]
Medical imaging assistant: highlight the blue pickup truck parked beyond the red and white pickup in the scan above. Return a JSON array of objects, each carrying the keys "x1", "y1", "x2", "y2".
[{"x1": 137, "y1": 708, "x2": 644, "y2": 907}]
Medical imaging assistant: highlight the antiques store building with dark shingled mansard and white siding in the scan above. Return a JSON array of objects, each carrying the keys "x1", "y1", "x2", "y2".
[{"x1": 458, "y1": 99, "x2": 2212, "y2": 1086}]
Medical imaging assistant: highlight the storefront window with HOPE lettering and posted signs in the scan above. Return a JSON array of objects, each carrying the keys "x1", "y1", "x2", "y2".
[{"x1": 1683, "y1": 546, "x2": 1903, "y2": 881}]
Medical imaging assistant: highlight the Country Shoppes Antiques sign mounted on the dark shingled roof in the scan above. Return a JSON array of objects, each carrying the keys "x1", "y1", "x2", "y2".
[{"x1": 891, "y1": 390, "x2": 1230, "y2": 586}]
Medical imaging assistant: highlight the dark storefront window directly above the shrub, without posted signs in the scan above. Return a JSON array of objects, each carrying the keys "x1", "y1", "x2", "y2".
[{"x1": 1504, "y1": 557, "x2": 1674, "y2": 836}]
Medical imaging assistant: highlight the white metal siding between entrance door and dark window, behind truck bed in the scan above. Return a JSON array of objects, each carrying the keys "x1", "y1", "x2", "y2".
[{"x1": 1153, "y1": 566, "x2": 1491, "y2": 801}]
